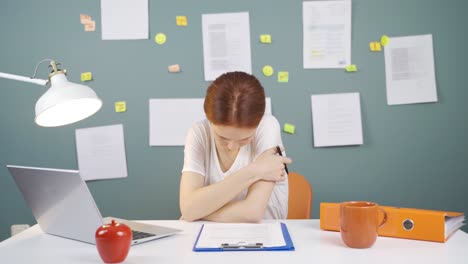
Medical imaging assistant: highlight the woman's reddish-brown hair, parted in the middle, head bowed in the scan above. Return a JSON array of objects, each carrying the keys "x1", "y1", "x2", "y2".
[{"x1": 204, "y1": 72, "x2": 265, "y2": 128}]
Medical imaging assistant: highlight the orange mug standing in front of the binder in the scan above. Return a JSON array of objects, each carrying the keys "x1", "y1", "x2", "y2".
[{"x1": 340, "y1": 201, "x2": 387, "y2": 248}]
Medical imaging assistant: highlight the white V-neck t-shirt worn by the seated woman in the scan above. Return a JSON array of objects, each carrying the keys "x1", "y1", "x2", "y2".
[{"x1": 182, "y1": 114, "x2": 288, "y2": 219}]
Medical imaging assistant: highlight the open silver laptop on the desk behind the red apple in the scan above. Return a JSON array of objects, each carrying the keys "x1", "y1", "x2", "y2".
[{"x1": 7, "y1": 165, "x2": 182, "y2": 245}]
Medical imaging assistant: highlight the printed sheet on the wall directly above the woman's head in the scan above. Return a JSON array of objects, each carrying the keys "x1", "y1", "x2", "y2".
[{"x1": 202, "y1": 12, "x2": 252, "y2": 81}]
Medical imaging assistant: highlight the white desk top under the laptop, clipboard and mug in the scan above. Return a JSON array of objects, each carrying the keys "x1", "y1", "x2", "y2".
[{"x1": 0, "y1": 220, "x2": 468, "y2": 264}]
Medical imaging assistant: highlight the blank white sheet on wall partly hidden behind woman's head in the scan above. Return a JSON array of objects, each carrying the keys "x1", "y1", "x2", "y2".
[{"x1": 149, "y1": 97, "x2": 271, "y2": 146}]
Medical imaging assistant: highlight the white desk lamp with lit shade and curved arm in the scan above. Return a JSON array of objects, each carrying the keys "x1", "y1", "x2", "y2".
[{"x1": 0, "y1": 59, "x2": 102, "y2": 127}]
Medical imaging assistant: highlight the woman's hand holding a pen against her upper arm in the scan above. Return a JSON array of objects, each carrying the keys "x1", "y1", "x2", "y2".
[{"x1": 250, "y1": 147, "x2": 292, "y2": 182}]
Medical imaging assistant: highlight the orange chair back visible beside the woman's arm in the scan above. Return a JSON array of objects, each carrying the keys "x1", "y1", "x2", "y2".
[{"x1": 288, "y1": 172, "x2": 312, "y2": 219}]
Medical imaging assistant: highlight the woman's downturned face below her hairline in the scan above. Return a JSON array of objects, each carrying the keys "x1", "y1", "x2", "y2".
[{"x1": 211, "y1": 123, "x2": 257, "y2": 151}]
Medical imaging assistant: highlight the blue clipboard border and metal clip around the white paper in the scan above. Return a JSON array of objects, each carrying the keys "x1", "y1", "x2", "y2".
[{"x1": 193, "y1": 223, "x2": 295, "y2": 252}]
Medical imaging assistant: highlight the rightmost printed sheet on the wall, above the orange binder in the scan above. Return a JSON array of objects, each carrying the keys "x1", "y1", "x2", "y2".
[{"x1": 385, "y1": 35, "x2": 437, "y2": 105}]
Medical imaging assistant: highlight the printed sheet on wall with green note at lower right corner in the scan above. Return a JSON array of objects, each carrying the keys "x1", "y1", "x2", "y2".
[{"x1": 302, "y1": 0, "x2": 351, "y2": 69}]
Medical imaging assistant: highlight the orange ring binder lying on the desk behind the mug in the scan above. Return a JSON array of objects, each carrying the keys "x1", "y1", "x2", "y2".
[{"x1": 320, "y1": 203, "x2": 465, "y2": 242}]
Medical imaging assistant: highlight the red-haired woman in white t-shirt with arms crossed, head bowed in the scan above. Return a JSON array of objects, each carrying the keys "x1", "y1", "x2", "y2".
[{"x1": 180, "y1": 72, "x2": 291, "y2": 222}]
